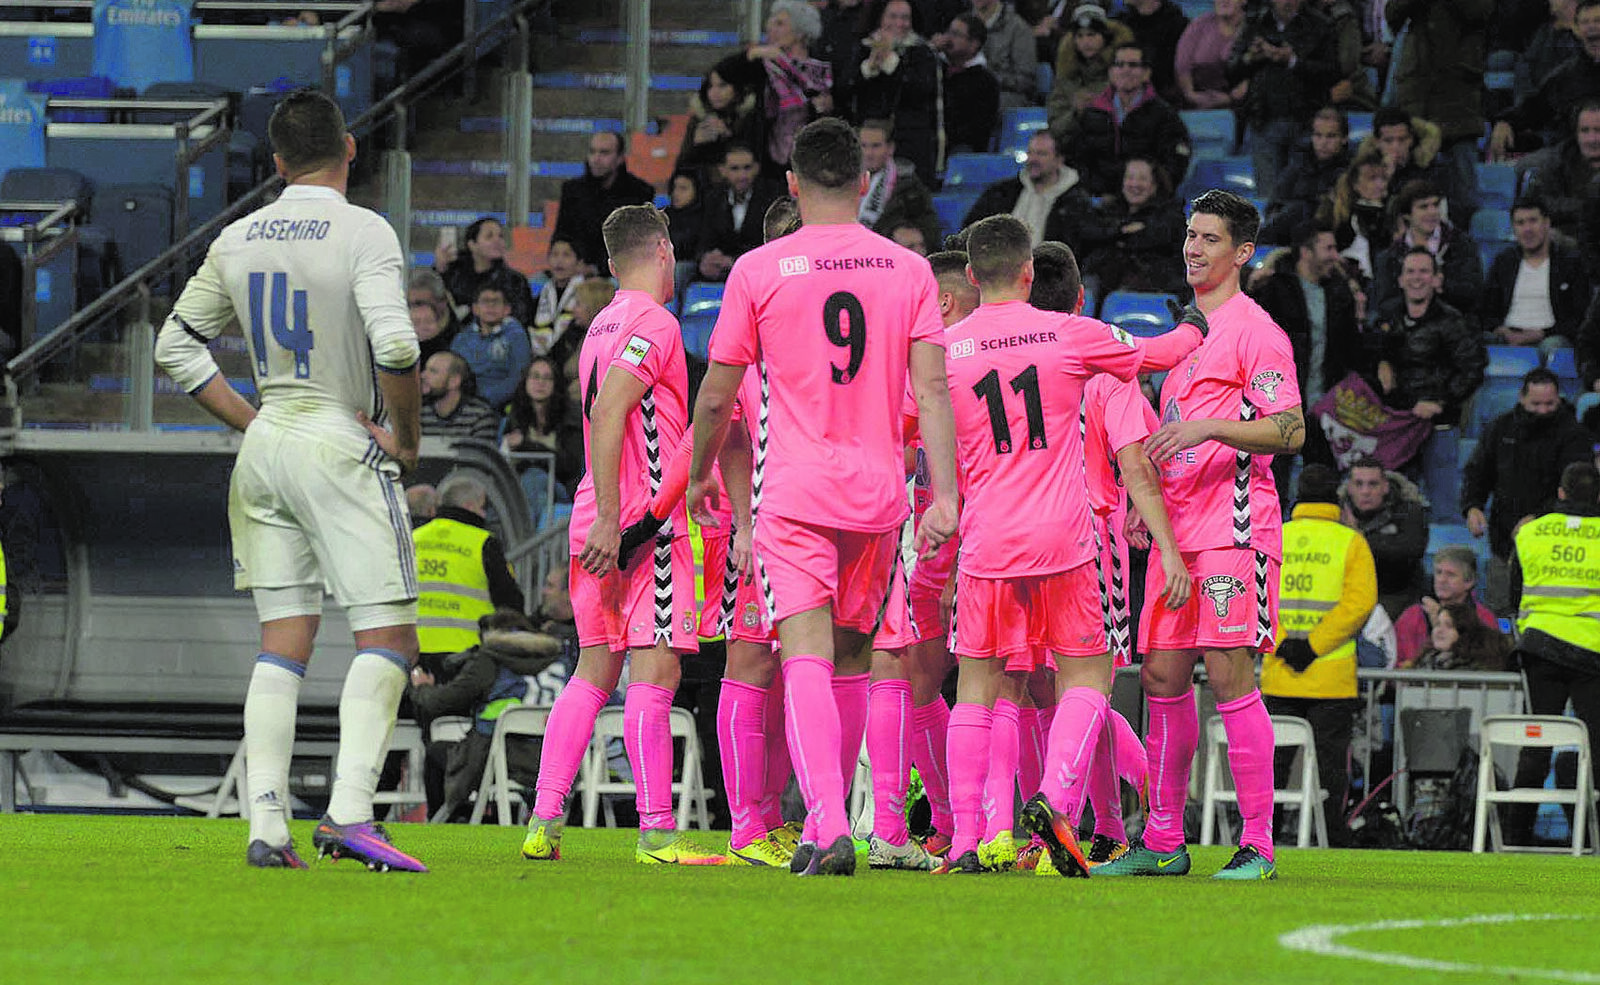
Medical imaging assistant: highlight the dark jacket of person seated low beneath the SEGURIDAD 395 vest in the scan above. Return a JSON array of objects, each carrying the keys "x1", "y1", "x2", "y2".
[{"x1": 411, "y1": 632, "x2": 562, "y2": 804}]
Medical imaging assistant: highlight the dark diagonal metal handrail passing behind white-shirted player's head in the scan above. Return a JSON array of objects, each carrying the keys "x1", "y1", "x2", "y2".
[{"x1": 0, "y1": 0, "x2": 549, "y2": 388}]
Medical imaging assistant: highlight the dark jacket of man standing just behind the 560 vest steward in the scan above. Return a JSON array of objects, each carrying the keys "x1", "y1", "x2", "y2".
[{"x1": 1461, "y1": 400, "x2": 1594, "y2": 558}]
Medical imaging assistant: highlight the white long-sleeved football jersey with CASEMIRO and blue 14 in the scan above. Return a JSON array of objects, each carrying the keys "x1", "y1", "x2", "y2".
[{"x1": 155, "y1": 185, "x2": 419, "y2": 462}]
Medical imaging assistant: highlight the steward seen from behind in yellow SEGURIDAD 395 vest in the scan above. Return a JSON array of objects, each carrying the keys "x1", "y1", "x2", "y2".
[{"x1": 411, "y1": 477, "x2": 525, "y2": 654}]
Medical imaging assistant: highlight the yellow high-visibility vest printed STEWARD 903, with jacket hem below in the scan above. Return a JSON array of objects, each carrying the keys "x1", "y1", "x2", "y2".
[{"x1": 1261, "y1": 518, "x2": 1360, "y2": 697}]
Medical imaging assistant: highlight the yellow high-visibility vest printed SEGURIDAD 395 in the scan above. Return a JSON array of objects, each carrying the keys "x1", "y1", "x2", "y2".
[{"x1": 411, "y1": 518, "x2": 494, "y2": 654}]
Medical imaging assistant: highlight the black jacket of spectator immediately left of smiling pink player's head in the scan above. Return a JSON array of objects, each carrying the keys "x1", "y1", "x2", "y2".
[{"x1": 1078, "y1": 195, "x2": 1184, "y2": 297}]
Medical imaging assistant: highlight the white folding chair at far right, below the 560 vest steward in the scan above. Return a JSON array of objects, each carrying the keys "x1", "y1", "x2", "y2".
[{"x1": 1472, "y1": 715, "x2": 1600, "y2": 855}]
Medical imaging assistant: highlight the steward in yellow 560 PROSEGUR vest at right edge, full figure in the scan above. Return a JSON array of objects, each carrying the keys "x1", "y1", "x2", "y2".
[{"x1": 1506, "y1": 462, "x2": 1600, "y2": 844}]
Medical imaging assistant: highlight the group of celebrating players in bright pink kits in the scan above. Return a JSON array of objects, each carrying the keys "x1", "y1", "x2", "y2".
[{"x1": 522, "y1": 113, "x2": 1304, "y2": 879}]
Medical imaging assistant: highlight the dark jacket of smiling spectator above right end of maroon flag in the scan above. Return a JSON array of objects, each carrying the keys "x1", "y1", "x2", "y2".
[{"x1": 1373, "y1": 297, "x2": 1490, "y2": 424}]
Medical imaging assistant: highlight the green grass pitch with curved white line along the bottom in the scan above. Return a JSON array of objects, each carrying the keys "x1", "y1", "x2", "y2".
[{"x1": 0, "y1": 814, "x2": 1600, "y2": 985}]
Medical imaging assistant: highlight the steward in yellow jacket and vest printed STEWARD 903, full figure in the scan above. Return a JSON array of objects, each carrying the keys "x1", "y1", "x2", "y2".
[{"x1": 1261, "y1": 464, "x2": 1378, "y2": 846}]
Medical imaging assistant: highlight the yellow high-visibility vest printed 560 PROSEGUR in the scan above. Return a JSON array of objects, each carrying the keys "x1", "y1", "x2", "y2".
[{"x1": 1517, "y1": 513, "x2": 1600, "y2": 652}]
